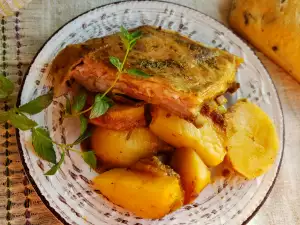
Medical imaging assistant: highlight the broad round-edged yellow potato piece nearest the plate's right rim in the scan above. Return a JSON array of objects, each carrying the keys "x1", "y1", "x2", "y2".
[{"x1": 225, "y1": 100, "x2": 279, "y2": 179}]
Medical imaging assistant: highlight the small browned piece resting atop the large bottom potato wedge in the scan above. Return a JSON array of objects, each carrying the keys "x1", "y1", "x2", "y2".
[{"x1": 130, "y1": 156, "x2": 179, "y2": 178}]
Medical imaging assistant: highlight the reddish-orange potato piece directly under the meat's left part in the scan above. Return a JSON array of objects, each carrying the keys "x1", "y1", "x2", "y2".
[{"x1": 89, "y1": 105, "x2": 146, "y2": 130}]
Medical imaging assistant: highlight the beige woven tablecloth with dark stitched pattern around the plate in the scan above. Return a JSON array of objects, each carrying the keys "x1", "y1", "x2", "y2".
[{"x1": 0, "y1": 0, "x2": 300, "y2": 225}]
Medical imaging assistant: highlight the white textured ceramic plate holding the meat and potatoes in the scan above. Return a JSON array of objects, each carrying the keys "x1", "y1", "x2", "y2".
[{"x1": 18, "y1": 1, "x2": 284, "y2": 225}]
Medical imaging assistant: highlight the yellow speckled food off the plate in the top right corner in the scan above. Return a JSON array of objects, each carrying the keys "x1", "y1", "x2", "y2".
[{"x1": 229, "y1": 0, "x2": 300, "y2": 81}]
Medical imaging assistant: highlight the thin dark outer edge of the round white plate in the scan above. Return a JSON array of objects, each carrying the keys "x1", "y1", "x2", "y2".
[{"x1": 15, "y1": 0, "x2": 285, "y2": 225}]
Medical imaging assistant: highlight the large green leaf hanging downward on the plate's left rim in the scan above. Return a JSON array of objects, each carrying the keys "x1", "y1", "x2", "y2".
[{"x1": 32, "y1": 127, "x2": 56, "y2": 164}]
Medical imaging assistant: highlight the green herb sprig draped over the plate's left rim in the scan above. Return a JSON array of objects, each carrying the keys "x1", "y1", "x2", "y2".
[{"x1": 0, "y1": 75, "x2": 97, "y2": 175}]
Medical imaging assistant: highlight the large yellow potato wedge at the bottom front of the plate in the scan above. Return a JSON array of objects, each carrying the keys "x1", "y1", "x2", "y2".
[{"x1": 94, "y1": 168, "x2": 183, "y2": 219}]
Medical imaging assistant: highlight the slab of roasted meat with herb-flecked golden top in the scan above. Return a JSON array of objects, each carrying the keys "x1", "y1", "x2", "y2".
[{"x1": 52, "y1": 26, "x2": 242, "y2": 117}]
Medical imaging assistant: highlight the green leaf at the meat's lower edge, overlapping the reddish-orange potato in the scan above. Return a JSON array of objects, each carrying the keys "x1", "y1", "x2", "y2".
[{"x1": 90, "y1": 94, "x2": 112, "y2": 119}]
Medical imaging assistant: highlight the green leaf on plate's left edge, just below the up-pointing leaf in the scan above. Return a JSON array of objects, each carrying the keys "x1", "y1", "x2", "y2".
[{"x1": 8, "y1": 109, "x2": 38, "y2": 130}]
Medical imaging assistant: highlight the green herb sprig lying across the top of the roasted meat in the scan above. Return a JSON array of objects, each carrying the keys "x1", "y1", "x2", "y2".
[{"x1": 66, "y1": 26, "x2": 151, "y2": 119}]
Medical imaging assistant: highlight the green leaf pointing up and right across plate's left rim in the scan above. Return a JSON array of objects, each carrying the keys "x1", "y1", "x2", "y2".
[{"x1": 19, "y1": 92, "x2": 53, "y2": 115}]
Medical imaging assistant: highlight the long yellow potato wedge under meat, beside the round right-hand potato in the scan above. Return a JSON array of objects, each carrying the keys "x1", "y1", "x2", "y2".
[{"x1": 150, "y1": 108, "x2": 226, "y2": 166}]
